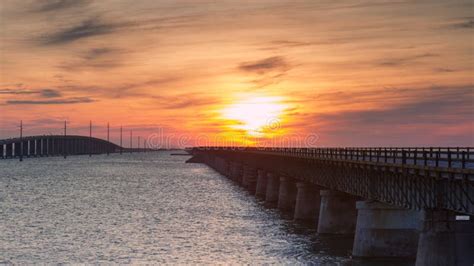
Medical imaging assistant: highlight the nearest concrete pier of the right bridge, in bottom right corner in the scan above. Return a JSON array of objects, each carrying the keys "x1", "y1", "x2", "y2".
[{"x1": 416, "y1": 210, "x2": 474, "y2": 266}]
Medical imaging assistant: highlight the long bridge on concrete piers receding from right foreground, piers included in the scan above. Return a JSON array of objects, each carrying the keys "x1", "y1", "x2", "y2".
[{"x1": 188, "y1": 147, "x2": 474, "y2": 266}]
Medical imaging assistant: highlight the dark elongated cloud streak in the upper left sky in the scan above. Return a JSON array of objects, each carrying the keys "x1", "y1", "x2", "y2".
[{"x1": 41, "y1": 19, "x2": 118, "y2": 45}]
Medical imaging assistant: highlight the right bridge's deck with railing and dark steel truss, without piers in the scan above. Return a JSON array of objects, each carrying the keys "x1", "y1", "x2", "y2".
[{"x1": 192, "y1": 147, "x2": 474, "y2": 214}]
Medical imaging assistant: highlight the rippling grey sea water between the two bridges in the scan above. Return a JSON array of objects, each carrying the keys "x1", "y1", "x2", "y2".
[{"x1": 0, "y1": 152, "x2": 406, "y2": 265}]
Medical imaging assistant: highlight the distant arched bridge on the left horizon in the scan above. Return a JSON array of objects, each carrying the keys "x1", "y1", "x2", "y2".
[{"x1": 0, "y1": 135, "x2": 124, "y2": 159}]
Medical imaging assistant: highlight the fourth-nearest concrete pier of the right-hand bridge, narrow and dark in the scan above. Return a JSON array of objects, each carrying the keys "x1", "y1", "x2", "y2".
[{"x1": 294, "y1": 182, "x2": 320, "y2": 222}]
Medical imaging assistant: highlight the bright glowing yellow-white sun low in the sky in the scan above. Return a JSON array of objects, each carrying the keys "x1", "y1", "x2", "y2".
[{"x1": 222, "y1": 97, "x2": 286, "y2": 137}]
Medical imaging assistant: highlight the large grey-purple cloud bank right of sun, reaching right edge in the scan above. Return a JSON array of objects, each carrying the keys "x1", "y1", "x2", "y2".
[{"x1": 315, "y1": 86, "x2": 474, "y2": 128}]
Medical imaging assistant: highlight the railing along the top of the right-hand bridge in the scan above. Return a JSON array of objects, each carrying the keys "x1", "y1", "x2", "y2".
[{"x1": 193, "y1": 147, "x2": 474, "y2": 169}]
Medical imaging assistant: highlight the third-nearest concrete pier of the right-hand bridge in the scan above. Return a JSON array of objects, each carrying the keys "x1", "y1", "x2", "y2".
[{"x1": 318, "y1": 190, "x2": 357, "y2": 234}]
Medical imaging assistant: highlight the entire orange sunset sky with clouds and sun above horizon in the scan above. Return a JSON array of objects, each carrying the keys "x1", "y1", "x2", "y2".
[{"x1": 0, "y1": 0, "x2": 474, "y2": 146}]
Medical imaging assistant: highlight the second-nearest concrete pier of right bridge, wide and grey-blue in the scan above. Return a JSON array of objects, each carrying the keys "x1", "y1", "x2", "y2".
[{"x1": 352, "y1": 201, "x2": 420, "y2": 258}]
